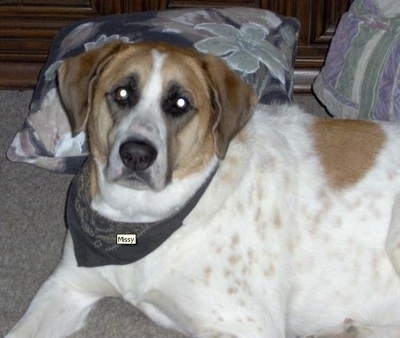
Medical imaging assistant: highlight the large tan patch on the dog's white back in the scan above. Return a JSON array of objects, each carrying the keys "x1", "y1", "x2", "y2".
[{"x1": 311, "y1": 119, "x2": 386, "y2": 189}]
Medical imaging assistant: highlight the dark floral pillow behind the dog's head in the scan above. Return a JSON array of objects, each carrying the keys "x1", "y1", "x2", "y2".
[{"x1": 7, "y1": 8, "x2": 299, "y2": 173}]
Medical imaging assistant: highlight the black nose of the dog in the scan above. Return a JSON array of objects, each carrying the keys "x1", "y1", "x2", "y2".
[{"x1": 119, "y1": 140, "x2": 157, "y2": 171}]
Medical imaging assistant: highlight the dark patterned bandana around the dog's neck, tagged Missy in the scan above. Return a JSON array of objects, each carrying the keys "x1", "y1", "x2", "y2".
[{"x1": 66, "y1": 160, "x2": 217, "y2": 267}]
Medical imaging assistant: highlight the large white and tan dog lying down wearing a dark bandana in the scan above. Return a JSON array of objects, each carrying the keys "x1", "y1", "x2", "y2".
[{"x1": 8, "y1": 42, "x2": 400, "y2": 338}]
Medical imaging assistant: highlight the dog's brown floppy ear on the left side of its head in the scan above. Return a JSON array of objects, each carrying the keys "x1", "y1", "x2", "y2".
[{"x1": 58, "y1": 41, "x2": 126, "y2": 135}]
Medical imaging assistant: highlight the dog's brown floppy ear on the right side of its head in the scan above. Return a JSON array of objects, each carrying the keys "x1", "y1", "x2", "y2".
[{"x1": 203, "y1": 55, "x2": 257, "y2": 159}]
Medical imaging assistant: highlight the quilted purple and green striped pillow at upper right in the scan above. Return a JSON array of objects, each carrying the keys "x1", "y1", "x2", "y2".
[{"x1": 313, "y1": 0, "x2": 400, "y2": 121}]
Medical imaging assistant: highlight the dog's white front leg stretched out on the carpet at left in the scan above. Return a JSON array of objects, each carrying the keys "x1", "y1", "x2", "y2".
[{"x1": 6, "y1": 235, "x2": 116, "y2": 338}]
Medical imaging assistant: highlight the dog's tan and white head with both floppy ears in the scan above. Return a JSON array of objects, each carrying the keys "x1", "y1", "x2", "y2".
[{"x1": 58, "y1": 42, "x2": 256, "y2": 191}]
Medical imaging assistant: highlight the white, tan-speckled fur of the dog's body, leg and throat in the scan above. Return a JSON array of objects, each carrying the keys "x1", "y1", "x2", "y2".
[{"x1": 8, "y1": 106, "x2": 400, "y2": 338}]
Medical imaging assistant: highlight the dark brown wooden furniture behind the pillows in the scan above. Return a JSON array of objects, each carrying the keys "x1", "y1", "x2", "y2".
[{"x1": 0, "y1": 0, "x2": 351, "y2": 92}]
